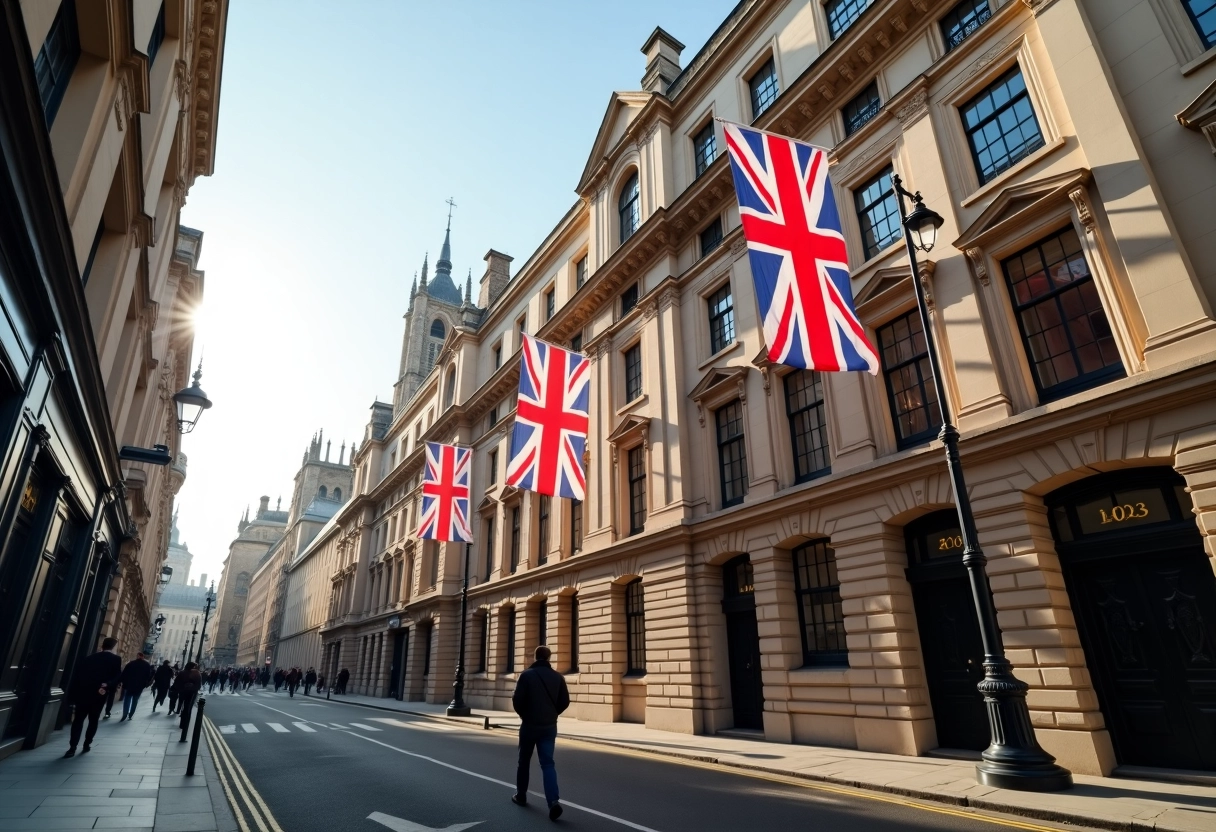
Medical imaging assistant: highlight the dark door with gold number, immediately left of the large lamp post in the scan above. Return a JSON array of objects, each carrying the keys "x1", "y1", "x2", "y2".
[{"x1": 906, "y1": 508, "x2": 990, "y2": 751}]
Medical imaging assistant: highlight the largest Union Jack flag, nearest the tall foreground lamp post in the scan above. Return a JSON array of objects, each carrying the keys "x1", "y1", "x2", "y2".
[{"x1": 725, "y1": 123, "x2": 878, "y2": 375}]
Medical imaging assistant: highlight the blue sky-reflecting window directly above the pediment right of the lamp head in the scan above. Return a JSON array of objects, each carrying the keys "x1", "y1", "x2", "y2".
[{"x1": 961, "y1": 67, "x2": 1043, "y2": 185}]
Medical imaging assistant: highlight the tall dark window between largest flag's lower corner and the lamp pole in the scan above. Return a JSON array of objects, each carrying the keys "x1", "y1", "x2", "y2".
[{"x1": 878, "y1": 309, "x2": 941, "y2": 448}]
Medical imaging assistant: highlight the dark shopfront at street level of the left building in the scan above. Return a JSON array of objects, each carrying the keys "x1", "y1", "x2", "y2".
[{"x1": 0, "y1": 6, "x2": 130, "y2": 758}]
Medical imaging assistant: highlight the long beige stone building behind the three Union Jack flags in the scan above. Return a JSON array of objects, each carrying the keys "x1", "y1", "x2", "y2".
[{"x1": 296, "y1": 0, "x2": 1216, "y2": 774}]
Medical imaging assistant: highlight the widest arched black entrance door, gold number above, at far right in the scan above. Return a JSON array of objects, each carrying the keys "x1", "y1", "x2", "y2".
[{"x1": 1048, "y1": 468, "x2": 1216, "y2": 769}]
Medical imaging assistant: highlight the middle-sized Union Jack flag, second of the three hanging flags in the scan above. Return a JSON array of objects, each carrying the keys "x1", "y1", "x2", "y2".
[{"x1": 507, "y1": 335, "x2": 591, "y2": 500}]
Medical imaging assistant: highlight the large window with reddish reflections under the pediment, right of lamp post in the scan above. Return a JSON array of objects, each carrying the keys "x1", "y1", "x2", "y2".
[{"x1": 1001, "y1": 226, "x2": 1125, "y2": 400}]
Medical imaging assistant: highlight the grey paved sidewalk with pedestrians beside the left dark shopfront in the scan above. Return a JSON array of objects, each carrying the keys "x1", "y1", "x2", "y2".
[{"x1": 0, "y1": 699, "x2": 237, "y2": 832}]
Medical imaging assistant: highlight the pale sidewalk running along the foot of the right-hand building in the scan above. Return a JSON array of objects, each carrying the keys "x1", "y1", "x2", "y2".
[{"x1": 314, "y1": 695, "x2": 1216, "y2": 832}]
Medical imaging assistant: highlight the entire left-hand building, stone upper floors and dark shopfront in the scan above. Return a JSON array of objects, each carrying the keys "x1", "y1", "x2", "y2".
[{"x1": 0, "y1": 0, "x2": 229, "y2": 758}]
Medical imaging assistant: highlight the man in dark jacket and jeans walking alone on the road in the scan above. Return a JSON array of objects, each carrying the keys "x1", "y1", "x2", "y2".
[{"x1": 511, "y1": 646, "x2": 570, "y2": 820}]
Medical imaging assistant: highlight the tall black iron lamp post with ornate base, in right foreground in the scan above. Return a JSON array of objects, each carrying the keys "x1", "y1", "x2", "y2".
[{"x1": 891, "y1": 175, "x2": 1073, "y2": 792}]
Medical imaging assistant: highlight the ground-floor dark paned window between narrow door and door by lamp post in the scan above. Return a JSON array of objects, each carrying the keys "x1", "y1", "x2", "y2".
[{"x1": 793, "y1": 540, "x2": 849, "y2": 667}]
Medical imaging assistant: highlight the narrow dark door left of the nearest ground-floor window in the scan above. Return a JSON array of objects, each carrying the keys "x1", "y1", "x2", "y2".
[{"x1": 722, "y1": 555, "x2": 764, "y2": 730}]
